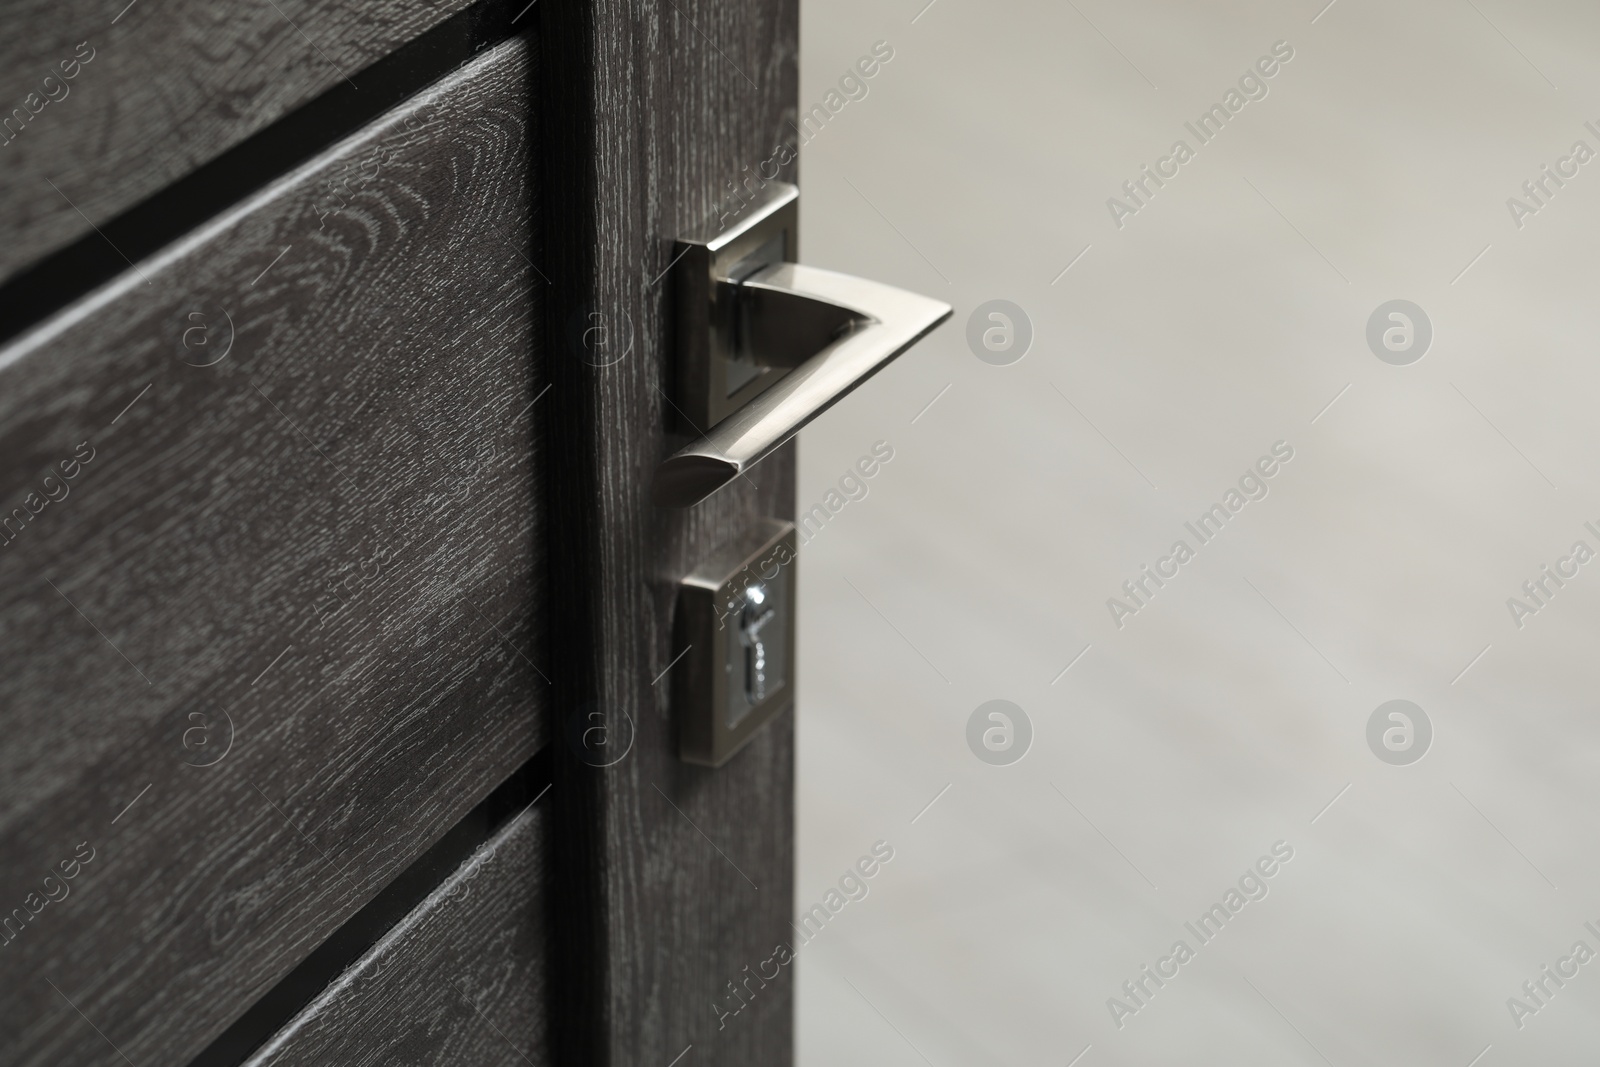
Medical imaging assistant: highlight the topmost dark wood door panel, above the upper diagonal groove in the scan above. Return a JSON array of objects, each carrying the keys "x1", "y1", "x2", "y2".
[{"x1": 0, "y1": 0, "x2": 469, "y2": 280}]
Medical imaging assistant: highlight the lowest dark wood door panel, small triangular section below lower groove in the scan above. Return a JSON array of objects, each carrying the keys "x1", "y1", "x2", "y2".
[{"x1": 246, "y1": 808, "x2": 552, "y2": 1067}]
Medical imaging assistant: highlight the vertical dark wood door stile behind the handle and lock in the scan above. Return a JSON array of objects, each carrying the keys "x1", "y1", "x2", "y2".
[{"x1": 539, "y1": 0, "x2": 797, "y2": 1067}]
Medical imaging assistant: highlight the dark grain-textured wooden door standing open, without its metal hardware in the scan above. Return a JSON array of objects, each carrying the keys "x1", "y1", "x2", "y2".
[{"x1": 0, "y1": 0, "x2": 797, "y2": 1067}]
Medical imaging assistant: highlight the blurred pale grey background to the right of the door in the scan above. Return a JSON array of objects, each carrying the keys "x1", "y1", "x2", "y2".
[{"x1": 795, "y1": 0, "x2": 1600, "y2": 1067}]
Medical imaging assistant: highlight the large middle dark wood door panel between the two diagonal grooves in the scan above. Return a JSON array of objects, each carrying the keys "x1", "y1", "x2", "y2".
[{"x1": 0, "y1": 42, "x2": 547, "y2": 1067}]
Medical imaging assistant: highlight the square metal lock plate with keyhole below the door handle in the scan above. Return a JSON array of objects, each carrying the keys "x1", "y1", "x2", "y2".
[{"x1": 672, "y1": 518, "x2": 795, "y2": 766}]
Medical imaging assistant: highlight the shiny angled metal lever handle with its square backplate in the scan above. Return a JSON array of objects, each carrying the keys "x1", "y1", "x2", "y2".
[{"x1": 651, "y1": 182, "x2": 950, "y2": 507}]
